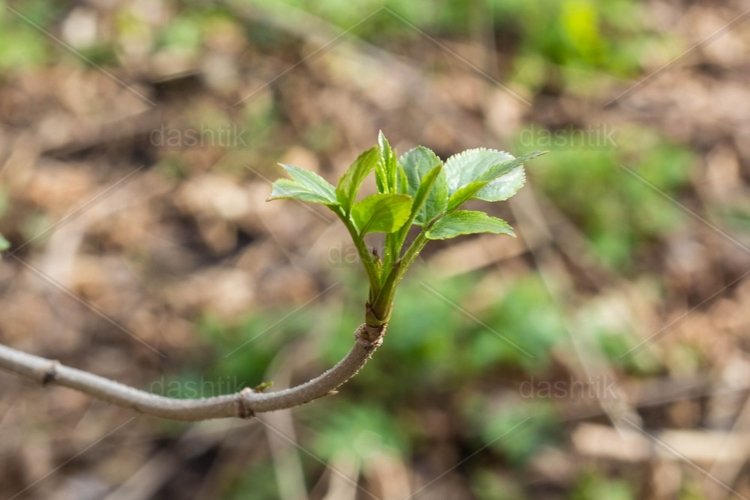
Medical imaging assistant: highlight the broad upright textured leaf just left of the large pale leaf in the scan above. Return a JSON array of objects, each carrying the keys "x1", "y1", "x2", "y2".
[{"x1": 399, "y1": 146, "x2": 448, "y2": 225}]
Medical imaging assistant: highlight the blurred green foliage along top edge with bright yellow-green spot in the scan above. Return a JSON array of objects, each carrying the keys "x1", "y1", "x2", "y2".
[{"x1": 248, "y1": 0, "x2": 663, "y2": 95}]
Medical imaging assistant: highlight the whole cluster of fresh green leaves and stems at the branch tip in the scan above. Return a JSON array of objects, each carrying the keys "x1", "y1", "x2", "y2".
[{"x1": 269, "y1": 132, "x2": 542, "y2": 325}]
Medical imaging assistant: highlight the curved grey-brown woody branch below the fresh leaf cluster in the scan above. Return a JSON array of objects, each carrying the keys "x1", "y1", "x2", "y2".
[{"x1": 0, "y1": 324, "x2": 385, "y2": 421}]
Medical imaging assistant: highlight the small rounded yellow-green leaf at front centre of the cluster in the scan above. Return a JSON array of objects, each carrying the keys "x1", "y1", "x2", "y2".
[{"x1": 352, "y1": 193, "x2": 412, "y2": 235}]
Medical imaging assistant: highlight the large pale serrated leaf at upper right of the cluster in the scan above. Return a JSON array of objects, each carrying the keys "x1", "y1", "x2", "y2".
[{"x1": 445, "y1": 148, "x2": 544, "y2": 203}]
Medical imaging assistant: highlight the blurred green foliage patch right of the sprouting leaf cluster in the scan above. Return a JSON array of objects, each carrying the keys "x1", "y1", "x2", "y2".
[{"x1": 520, "y1": 129, "x2": 694, "y2": 269}]
